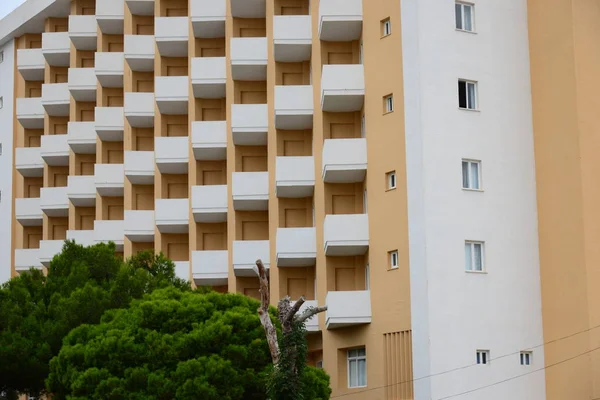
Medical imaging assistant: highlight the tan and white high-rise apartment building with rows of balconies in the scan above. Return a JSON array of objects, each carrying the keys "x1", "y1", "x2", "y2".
[{"x1": 0, "y1": 0, "x2": 600, "y2": 400}]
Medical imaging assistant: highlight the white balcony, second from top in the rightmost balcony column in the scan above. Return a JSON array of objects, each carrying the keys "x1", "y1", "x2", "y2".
[{"x1": 321, "y1": 64, "x2": 365, "y2": 112}]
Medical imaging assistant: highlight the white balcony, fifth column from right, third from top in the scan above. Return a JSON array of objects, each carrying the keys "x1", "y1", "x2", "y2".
[{"x1": 154, "y1": 136, "x2": 190, "y2": 174}]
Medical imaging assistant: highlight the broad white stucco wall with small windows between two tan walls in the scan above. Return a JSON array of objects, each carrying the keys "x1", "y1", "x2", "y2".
[{"x1": 401, "y1": 0, "x2": 545, "y2": 400}]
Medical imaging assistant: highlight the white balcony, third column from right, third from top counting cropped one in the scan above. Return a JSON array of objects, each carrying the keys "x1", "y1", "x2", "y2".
[{"x1": 231, "y1": 104, "x2": 269, "y2": 146}]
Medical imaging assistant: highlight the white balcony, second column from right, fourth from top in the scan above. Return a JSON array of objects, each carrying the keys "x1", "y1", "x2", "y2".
[{"x1": 276, "y1": 228, "x2": 317, "y2": 267}]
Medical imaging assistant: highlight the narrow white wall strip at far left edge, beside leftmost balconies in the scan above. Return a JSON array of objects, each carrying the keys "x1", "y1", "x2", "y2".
[{"x1": 0, "y1": 40, "x2": 15, "y2": 283}]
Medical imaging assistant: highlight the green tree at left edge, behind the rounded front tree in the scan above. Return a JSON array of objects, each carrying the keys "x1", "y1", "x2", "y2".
[{"x1": 0, "y1": 242, "x2": 190, "y2": 398}]
